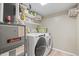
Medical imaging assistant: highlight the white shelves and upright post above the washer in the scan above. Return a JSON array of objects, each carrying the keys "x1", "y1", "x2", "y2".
[{"x1": 16, "y1": 3, "x2": 41, "y2": 25}]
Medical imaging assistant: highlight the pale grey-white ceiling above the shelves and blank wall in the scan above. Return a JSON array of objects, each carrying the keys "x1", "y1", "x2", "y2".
[{"x1": 26, "y1": 3, "x2": 76, "y2": 16}]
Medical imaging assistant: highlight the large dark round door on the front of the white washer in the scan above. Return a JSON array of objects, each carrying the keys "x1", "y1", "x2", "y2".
[{"x1": 35, "y1": 37, "x2": 46, "y2": 56}]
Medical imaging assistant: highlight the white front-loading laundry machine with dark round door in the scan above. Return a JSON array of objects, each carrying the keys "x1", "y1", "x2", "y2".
[{"x1": 27, "y1": 33, "x2": 52, "y2": 56}]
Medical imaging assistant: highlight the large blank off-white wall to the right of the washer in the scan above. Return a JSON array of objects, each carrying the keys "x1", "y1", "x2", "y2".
[{"x1": 41, "y1": 15, "x2": 76, "y2": 53}]
